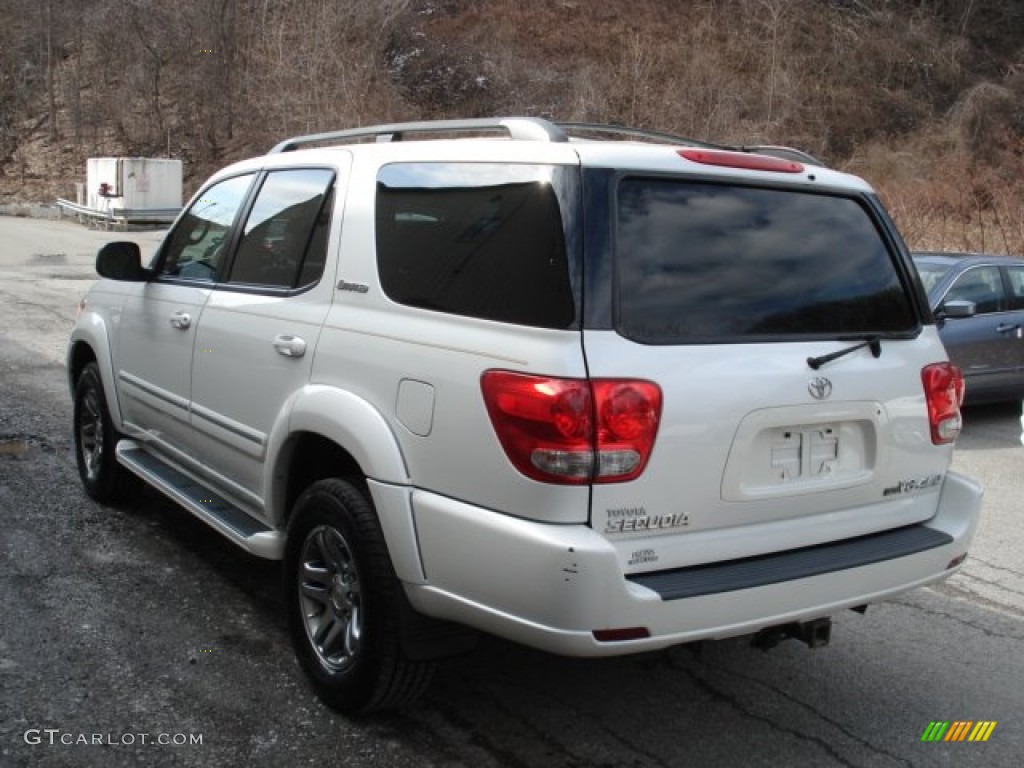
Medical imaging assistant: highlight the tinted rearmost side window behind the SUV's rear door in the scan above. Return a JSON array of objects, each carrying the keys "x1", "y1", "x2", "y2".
[{"x1": 376, "y1": 163, "x2": 577, "y2": 329}]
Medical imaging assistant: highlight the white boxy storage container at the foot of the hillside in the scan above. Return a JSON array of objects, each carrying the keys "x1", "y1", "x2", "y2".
[{"x1": 85, "y1": 158, "x2": 182, "y2": 211}]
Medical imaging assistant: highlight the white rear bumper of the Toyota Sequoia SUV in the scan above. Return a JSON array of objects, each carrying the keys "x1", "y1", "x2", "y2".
[{"x1": 406, "y1": 472, "x2": 982, "y2": 656}]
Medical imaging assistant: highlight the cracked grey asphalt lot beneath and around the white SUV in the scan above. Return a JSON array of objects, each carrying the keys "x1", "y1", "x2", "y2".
[{"x1": 0, "y1": 217, "x2": 1024, "y2": 768}]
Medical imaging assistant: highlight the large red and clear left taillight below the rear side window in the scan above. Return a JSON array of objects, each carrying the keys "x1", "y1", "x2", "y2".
[{"x1": 480, "y1": 371, "x2": 662, "y2": 484}]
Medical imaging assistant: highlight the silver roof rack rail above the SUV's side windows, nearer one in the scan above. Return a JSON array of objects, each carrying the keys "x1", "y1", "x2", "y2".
[{"x1": 268, "y1": 118, "x2": 568, "y2": 155}]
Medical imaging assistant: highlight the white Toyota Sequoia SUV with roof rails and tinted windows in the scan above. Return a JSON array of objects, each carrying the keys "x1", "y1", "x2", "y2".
[{"x1": 68, "y1": 118, "x2": 981, "y2": 713}]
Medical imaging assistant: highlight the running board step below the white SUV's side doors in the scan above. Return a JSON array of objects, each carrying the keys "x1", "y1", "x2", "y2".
[{"x1": 118, "y1": 440, "x2": 285, "y2": 560}]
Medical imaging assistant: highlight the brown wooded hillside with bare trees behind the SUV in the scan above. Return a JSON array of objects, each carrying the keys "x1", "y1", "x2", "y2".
[{"x1": 0, "y1": 0, "x2": 1024, "y2": 252}]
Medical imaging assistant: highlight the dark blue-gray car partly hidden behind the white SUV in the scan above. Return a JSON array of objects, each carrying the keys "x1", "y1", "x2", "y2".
[{"x1": 912, "y1": 253, "x2": 1024, "y2": 403}]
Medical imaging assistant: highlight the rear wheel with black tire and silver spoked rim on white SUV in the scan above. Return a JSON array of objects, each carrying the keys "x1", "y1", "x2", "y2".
[{"x1": 285, "y1": 478, "x2": 434, "y2": 715}]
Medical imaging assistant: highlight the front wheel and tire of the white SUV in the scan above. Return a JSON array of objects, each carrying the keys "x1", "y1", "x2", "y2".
[{"x1": 73, "y1": 362, "x2": 131, "y2": 504}]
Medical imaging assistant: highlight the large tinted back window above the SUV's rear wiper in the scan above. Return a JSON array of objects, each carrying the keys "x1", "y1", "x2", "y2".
[{"x1": 615, "y1": 178, "x2": 918, "y2": 344}]
